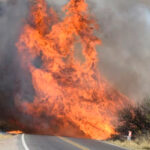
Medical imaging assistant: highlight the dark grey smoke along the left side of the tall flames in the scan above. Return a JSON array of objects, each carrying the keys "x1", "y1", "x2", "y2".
[{"x1": 0, "y1": 0, "x2": 27, "y2": 123}]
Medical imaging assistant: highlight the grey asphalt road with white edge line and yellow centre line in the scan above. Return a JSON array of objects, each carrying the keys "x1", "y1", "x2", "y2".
[{"x1": 17, "y1": 134, "x2": 125, "y2": 150}]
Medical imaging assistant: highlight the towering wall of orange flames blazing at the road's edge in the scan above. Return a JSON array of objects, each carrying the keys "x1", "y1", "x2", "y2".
[{"x1": 16, "y1": 0, "x2": 129, "y2": 139}]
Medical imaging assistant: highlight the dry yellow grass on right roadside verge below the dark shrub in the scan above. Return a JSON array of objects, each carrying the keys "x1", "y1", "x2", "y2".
[{"x1": 109, "y1": 138, "x2": 150, "y2": 150}]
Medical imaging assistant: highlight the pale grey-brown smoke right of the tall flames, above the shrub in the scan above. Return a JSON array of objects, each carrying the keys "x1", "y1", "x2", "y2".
[{"x1": 92, "y1": 0, "x2": 150, "y2": 100}]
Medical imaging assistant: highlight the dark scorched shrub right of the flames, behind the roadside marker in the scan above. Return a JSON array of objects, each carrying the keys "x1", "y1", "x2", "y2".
[{"x1": 116, "y1": 98, "x2": 150, "y2": 136}]
